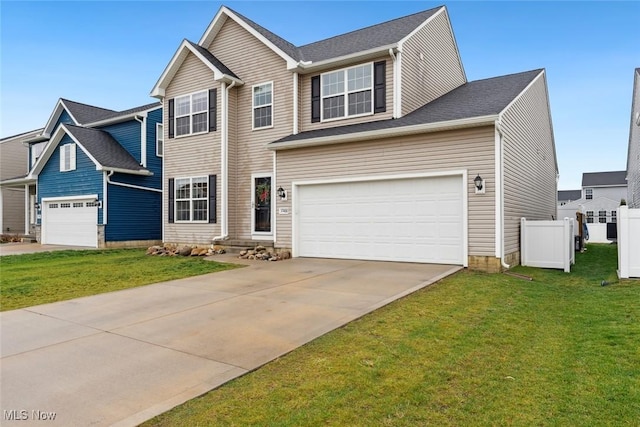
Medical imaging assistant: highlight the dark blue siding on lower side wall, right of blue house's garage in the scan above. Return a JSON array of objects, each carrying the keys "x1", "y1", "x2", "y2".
[{"x1": 105, "y1": 185, "x2": 162, "y2": 242}]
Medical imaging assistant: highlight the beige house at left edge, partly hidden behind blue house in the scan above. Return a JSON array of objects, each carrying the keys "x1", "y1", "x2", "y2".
[{"x1": 0, "y1": 129, "x2": 42, "y2": 235}]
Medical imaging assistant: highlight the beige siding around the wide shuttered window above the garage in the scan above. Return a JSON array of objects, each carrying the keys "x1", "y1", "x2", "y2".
[{"x1": 298, "y1": 55, "x2": 393, "y2": 132}]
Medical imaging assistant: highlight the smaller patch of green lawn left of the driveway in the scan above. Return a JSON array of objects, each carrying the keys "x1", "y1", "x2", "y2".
[{"x1": 0, "y1": 249, "x2": 237, "y2": 311}]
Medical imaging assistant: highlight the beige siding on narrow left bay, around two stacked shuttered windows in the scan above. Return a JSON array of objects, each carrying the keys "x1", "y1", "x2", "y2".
[{"x1": 162, "y1": 53, "x2": 222, "y2": 244}]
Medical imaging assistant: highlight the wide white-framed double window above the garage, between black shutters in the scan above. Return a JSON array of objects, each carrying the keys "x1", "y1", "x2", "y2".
[{"x1": 320, "y1": 63, "x2": 373, "y2": 120}]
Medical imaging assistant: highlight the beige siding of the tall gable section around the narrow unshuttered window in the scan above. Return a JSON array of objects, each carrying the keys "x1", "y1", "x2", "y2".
[{"x1": 208, "y1": 19, "x2": 293, "y2": 240}]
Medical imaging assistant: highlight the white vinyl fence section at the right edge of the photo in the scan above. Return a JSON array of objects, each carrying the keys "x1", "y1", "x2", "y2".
[{"x1": 618, "y1": 206, "x2": 640, "y2": 279}]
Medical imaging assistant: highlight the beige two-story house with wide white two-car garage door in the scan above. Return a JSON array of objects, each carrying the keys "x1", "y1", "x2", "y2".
[{"x1": 151, "y1": 6, "x2": 558, "y2": 271}]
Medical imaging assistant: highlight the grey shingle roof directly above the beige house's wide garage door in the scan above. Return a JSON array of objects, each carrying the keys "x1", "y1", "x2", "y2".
[{"x1": 272, "y1": 69, "x2": 542, "y2": 145}]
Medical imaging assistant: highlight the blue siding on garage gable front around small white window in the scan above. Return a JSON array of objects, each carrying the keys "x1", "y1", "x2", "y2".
[{"x1": 38, "y1": 135, "x2": 103, "y2": 224}]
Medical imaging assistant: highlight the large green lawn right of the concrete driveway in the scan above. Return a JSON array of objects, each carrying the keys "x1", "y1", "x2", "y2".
[{"x1": 145, "y1": 244, "x2": 640, "y2": 426}]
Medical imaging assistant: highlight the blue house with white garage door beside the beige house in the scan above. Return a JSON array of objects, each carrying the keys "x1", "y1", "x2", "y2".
[{"x1": 25, "y1": 99, "x2": 163, "y2": 247}]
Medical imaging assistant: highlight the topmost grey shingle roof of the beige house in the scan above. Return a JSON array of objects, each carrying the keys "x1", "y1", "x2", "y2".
[{"x1": 229, "y1": 6, "x2": 443, "y2": 62}]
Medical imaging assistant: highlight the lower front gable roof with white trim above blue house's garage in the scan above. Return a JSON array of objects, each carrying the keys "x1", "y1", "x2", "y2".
[{"x1": 28, "y1": 123, "x2": 151, "y2": 178}]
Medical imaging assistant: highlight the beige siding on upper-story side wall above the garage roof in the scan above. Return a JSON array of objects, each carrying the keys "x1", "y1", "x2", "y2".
[{"x1": 400, "y1": 8, "x2": 466, "y2": 115}]
